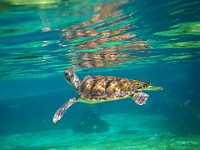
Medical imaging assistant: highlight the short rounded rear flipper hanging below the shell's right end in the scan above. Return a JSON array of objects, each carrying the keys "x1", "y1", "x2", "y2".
[{"x1": 130, "y1": 92, "x2": 149, "y2": 105}]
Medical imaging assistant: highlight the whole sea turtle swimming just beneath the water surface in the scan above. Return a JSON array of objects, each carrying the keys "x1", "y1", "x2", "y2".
[{"x1": 53, "y1": 68, "x2": 162, "y2": 123}]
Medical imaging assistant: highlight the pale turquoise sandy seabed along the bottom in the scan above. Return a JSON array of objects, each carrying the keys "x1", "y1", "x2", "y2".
[{"x1": 0, "y1": 114, "x2": 200, "y2": 150}]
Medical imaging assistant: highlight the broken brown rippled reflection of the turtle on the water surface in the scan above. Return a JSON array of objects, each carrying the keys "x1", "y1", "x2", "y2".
[{"x1": 62, "y1": 1, "x2": 150, "y2": 68}]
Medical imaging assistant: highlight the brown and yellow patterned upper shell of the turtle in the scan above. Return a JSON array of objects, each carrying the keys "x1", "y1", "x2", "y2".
[{"x1": 78, "y1": 76, "x2": 149, "y2": 100}]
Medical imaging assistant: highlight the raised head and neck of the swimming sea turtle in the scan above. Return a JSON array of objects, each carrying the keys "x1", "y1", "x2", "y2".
[{"x1": 64, "y1": 68, "x2": 80, "y2": 90}]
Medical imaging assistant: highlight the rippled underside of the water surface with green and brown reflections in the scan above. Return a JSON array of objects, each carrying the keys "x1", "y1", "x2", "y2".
[{"x1": 0, "y1": 0, "x2": 200, "y2": 79}]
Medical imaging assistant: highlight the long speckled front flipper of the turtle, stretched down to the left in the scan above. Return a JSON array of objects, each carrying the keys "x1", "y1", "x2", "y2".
[{"x1": 53, "y1": 98, "x2": 77, "y2": 123}]
